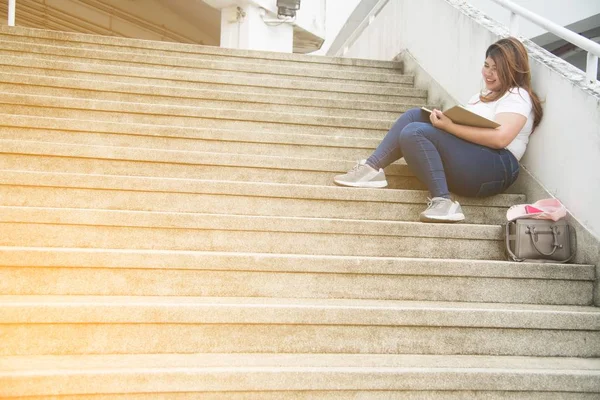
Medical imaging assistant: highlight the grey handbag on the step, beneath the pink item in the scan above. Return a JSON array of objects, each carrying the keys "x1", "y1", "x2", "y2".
[{"x1": 506, "y1": 218, "x2": 575, "y2": 263}]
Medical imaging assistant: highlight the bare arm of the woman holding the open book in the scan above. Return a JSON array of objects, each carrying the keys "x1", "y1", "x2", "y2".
[{"x1": 429, "y1": 110, "x2": 527, "y2": 149}]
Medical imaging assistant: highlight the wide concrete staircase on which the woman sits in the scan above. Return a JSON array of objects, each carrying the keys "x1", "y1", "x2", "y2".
[{"x1": 0, "y1": 27, "x2": 600, "y2": 400}]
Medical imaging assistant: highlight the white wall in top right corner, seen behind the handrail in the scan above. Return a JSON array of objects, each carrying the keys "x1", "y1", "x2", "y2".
[{"x1": 467, "y1": 0, "x2": 600, "y2": 38}]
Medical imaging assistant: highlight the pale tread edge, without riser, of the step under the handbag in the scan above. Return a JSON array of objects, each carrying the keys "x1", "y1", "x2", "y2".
[{"x1": 0, "y1": 246, "x2": 595, "y2": 281}]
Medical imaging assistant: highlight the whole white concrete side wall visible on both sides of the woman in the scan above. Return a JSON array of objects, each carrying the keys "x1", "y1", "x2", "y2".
[{"x1": 336, "y1": 0, "x2": 600, "y2": 304}]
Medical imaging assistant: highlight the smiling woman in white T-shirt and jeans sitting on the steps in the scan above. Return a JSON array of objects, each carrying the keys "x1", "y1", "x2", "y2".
[{"x1": 334, "y1": 37, "x2": 542, "y2": 222}]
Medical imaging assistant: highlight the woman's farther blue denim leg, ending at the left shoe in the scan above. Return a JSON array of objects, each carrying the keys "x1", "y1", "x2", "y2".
[{"x1": 367, "y1": 108, "x2": 428, "y2": 169}]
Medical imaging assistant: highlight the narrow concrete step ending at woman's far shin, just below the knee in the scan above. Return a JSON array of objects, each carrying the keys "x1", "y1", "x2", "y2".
[{"x1": 0, "y1": 93, "x2": 394, "y2": 130}]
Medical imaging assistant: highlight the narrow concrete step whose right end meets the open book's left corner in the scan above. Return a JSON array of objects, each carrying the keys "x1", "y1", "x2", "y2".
[{"x1": 0, "y1": 72, "x2": 418, "y2": 116}]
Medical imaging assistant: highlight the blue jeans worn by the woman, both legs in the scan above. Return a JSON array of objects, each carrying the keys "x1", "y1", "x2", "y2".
[{"x1": 367, "y1": 108, "x2": 519, "y2": 198}]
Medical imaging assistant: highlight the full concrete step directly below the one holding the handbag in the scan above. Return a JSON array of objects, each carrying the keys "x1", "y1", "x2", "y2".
[{"x1": 0, "y1": 296, "x2": 600, "y2": 357}]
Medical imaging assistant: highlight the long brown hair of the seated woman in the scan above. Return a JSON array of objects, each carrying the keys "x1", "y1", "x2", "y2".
[{"x1": 480, "y1": 37, "x2": 544, "y2": 129}]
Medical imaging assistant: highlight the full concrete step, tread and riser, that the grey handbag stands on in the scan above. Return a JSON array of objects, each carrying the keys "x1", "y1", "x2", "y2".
[{"x1": 0, "y1": 247, "x2": 595, "y2": 305}]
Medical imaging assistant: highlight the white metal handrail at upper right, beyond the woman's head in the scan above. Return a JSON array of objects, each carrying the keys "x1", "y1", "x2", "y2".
[{"x1": 492, "y1": 0, "x2": 600, "y2": 83}]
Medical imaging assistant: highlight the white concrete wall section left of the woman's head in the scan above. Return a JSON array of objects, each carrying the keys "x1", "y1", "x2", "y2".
[{"x1": 346, "y1": 0, "x2": 499, "y2": 108}]
